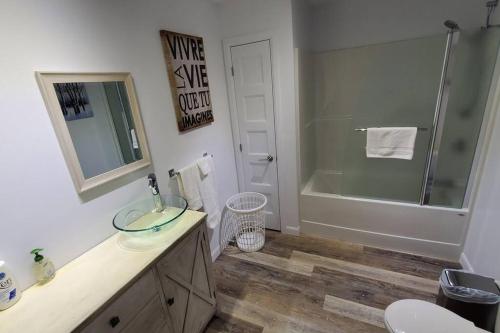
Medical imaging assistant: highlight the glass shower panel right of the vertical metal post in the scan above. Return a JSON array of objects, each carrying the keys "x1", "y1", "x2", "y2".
[{"x1": 429, "y1": 28, "x2": 500, "y2": 208}]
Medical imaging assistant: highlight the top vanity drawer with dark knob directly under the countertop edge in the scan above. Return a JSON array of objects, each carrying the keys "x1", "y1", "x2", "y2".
[{"x1": 82, "y1": 271, "x2": 157, "y2": 333}]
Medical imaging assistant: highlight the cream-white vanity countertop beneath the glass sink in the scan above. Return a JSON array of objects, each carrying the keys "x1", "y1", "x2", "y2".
[{"x1": 0, "y1": 210, "x2": 205, "y2": 333}]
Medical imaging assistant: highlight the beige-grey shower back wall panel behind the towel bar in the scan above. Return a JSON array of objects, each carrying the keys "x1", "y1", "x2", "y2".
[{"x1": 314, "y1": 34, "x2": 446, "y2": 202}]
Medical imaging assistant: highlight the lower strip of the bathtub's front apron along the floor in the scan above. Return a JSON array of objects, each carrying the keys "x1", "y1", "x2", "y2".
[{"x1": 300, "y1": 220, "x2": 462, "y2": 261}]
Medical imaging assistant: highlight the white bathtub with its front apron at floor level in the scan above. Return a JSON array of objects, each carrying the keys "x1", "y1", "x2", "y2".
[{"x1": 300, "y1": 170, "x2": 469, "y2": 261}]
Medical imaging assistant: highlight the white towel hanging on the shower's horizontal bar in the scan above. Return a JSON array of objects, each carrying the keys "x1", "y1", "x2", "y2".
[{"x1": 366, "y1": 127, "x2": 417, "y2": 160}]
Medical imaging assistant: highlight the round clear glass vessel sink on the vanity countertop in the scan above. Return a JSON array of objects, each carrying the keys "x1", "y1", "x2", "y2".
[{"x1": 113, "y1": 195, "x2": 187, "y2": 236}]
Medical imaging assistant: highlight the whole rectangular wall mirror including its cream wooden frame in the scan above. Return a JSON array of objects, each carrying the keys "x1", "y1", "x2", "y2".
[{"x1": 37, "y1": 72, "x2": 150, "y2": 193}]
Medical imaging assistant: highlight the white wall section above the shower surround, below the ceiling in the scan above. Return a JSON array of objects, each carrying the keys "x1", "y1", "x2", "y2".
[{"x1": 312, "y1": 0, "x2": 499, "y2": 50}]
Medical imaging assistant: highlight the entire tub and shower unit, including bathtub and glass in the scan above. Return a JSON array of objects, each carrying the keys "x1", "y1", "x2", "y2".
[{"x1": 296, "y1": 26, "x2": 500, "y2": 259}]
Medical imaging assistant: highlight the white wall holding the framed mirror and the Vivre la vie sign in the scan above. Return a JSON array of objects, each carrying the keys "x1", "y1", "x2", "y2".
[{"x1": 0, "y1": 0, "x2": 238, "y2": 287}]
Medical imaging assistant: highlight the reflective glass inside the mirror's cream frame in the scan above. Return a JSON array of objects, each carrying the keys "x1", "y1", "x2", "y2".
[{"x1": 54, "y1": 81, "x2": 142, "y2": 179}]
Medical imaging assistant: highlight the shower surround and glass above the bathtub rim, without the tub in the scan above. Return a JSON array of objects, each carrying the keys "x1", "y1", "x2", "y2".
[{"x1": 302, "y1": 29, "x2": 499, "y2": 208}]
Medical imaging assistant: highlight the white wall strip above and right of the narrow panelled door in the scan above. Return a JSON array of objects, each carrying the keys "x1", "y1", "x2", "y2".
[{"x1": 218, "y1": 0, "x2": 299, "y2": 233}]
